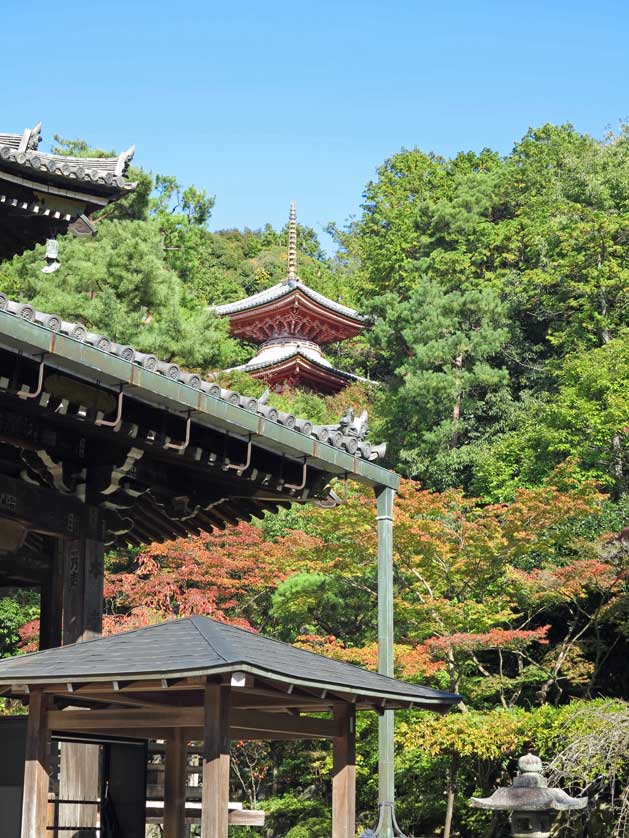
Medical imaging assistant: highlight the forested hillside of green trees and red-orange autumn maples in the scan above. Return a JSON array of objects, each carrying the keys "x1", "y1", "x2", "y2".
[{"x1": 0, "y1": 125, "x2": 629, "y2": 838}]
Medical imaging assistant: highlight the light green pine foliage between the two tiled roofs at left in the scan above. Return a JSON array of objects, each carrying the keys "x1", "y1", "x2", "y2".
[{"x1": 0, "y1": 221, "x2": 234, "y2": 368}]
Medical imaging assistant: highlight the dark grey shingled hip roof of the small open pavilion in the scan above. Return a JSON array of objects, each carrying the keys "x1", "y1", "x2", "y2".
[{"x1": 0, "y1": 617, "x2": 459, "y2": 710}]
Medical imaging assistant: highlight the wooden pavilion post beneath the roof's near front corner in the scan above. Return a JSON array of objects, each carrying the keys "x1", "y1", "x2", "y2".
[{"x1": 201, "y1": 683, "x2": 231, "y2": 838}]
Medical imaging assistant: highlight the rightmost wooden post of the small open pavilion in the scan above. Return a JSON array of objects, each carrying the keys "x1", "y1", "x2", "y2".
[{"x1": 332, "y1": 704, "x2": 356, "y2": 838}]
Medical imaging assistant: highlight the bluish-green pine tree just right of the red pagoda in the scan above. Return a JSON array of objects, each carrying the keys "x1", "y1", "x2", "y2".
[{"x1": 370, "y1": 277, "x2": 509, "y2": 489}]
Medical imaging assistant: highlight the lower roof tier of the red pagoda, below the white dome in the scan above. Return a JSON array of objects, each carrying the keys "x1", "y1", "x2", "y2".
[{"x1": 226, "y1": 348, "x2": 369, "y2": 393}]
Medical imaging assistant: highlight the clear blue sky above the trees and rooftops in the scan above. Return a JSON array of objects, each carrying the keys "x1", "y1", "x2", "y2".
[{"x1": 0, "y1": 0, "x2": 629, "y2": 246}]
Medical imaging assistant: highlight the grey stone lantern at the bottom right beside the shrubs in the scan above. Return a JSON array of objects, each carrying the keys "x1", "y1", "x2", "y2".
[{"x1": 470, "y1": 754, "x2": 588, "y2": 838}]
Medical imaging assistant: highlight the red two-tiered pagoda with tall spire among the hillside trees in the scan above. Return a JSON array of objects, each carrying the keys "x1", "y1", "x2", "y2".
[{"x1": 213, "y1": 203, "x2": 366, "y2": 394}]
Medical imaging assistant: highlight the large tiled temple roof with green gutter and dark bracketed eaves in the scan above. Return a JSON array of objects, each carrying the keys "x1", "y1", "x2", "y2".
[{"x1": 0, "y1": 286, "x2": 392, "y2": 560}]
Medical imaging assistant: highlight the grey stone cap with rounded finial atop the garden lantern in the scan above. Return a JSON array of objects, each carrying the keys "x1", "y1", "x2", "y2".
[{"x1": 470, "y1": 754, "x2": 588, "y2": 812}]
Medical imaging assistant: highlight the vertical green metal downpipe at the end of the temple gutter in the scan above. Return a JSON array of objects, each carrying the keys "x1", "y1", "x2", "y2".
[{"x1": 376, "y1": 487, "x2": 395, "y2": 838}]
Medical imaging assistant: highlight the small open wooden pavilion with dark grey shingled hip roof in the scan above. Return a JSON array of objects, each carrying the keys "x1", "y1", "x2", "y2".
[{"x1": 0, "y1": 617, "x2": 459, "y2": 838}]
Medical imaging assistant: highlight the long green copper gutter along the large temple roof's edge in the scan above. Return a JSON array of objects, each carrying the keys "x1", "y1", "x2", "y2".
[{"x1": 0, "y1": 312, "x2": 400, "y2": 490}]
